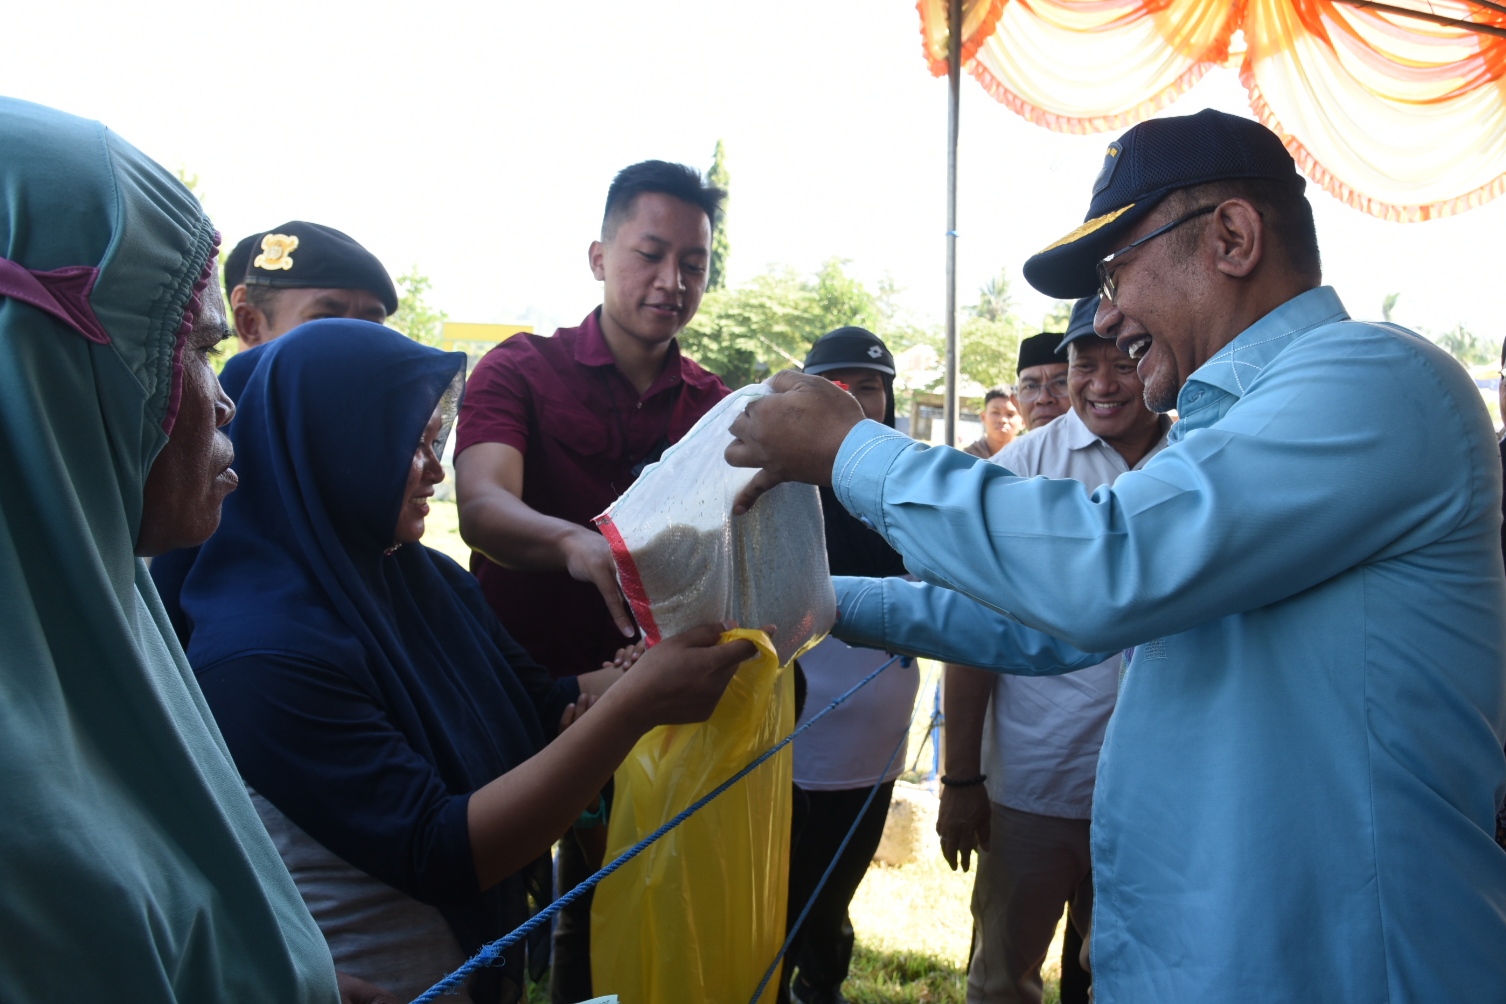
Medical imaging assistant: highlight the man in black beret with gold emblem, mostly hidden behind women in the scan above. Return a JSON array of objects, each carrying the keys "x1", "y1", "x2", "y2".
[{"x1": 224, "y1": 220, "x2": 398, "y2": 349}]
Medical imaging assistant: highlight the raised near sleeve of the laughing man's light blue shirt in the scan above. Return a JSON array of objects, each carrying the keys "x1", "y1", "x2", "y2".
[{"x1": 833, "y1": 322, "x2": 1495, "y2": 650}]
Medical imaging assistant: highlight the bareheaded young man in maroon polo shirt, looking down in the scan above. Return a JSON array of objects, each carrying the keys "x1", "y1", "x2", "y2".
[{"x1": 455, "y1": 161, "x2": 727, "y2": 1001}]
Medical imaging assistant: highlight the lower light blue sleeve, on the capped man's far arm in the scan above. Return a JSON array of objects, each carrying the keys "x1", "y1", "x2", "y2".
[{"x1": 831, "y1": 575, "x2": 1113, "y2": 676}]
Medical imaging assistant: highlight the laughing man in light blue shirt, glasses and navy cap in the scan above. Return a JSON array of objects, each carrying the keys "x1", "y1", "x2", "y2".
[{"x1": 727, "y1": 111, "x2": 1506, "y2": 1004}]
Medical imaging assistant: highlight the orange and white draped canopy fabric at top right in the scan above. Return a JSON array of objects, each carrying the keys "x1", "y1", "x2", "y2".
[{"x1": 916, "y1": 0, "x2": 1506, "y2": 221}]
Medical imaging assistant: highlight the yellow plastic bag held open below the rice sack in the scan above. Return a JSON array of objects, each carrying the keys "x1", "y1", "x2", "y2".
[{"x1": 590, "y1": 629, "x2": 795, "y2": 1004}]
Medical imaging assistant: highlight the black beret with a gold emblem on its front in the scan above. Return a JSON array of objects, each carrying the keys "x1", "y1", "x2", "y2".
[{"x1": 237, "y1": 220, "x2": 398, "y2": 315}]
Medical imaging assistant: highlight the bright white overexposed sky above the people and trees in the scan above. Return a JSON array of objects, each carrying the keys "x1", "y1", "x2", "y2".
[{"x1": 0, "y1": 0, "x2": 1506, "y2": 340}]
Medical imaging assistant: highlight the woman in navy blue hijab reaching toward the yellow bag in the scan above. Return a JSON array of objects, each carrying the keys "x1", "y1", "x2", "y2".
[{"x1": 182, "y1": 321, "x2": 753, "y2": 1004}]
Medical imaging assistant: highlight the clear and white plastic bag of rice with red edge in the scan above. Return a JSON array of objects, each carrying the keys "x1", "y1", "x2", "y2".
[{"x1": 596, "y1": 384, "x2": 836, "y2": 665}]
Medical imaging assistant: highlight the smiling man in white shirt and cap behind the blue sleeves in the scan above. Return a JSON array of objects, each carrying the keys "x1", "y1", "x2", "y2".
[{"x1": 937, "y1": 297, "x2": 1170, "y2": 1004}]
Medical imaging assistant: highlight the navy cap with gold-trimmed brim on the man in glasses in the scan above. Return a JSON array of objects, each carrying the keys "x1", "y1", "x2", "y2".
[{"x1": 1024, "y1": 108, "x2": 1306, "y2": 300}]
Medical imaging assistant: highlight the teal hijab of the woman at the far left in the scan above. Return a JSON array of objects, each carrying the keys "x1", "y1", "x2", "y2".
[{"x1": 0, "y1": 98, "x2": 339, "y2": 1004}]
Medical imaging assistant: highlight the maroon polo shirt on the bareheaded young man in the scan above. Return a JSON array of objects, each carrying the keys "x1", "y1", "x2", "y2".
[{"x1": 455, "y1": 310, "x2": 727, "y2": 676}]
